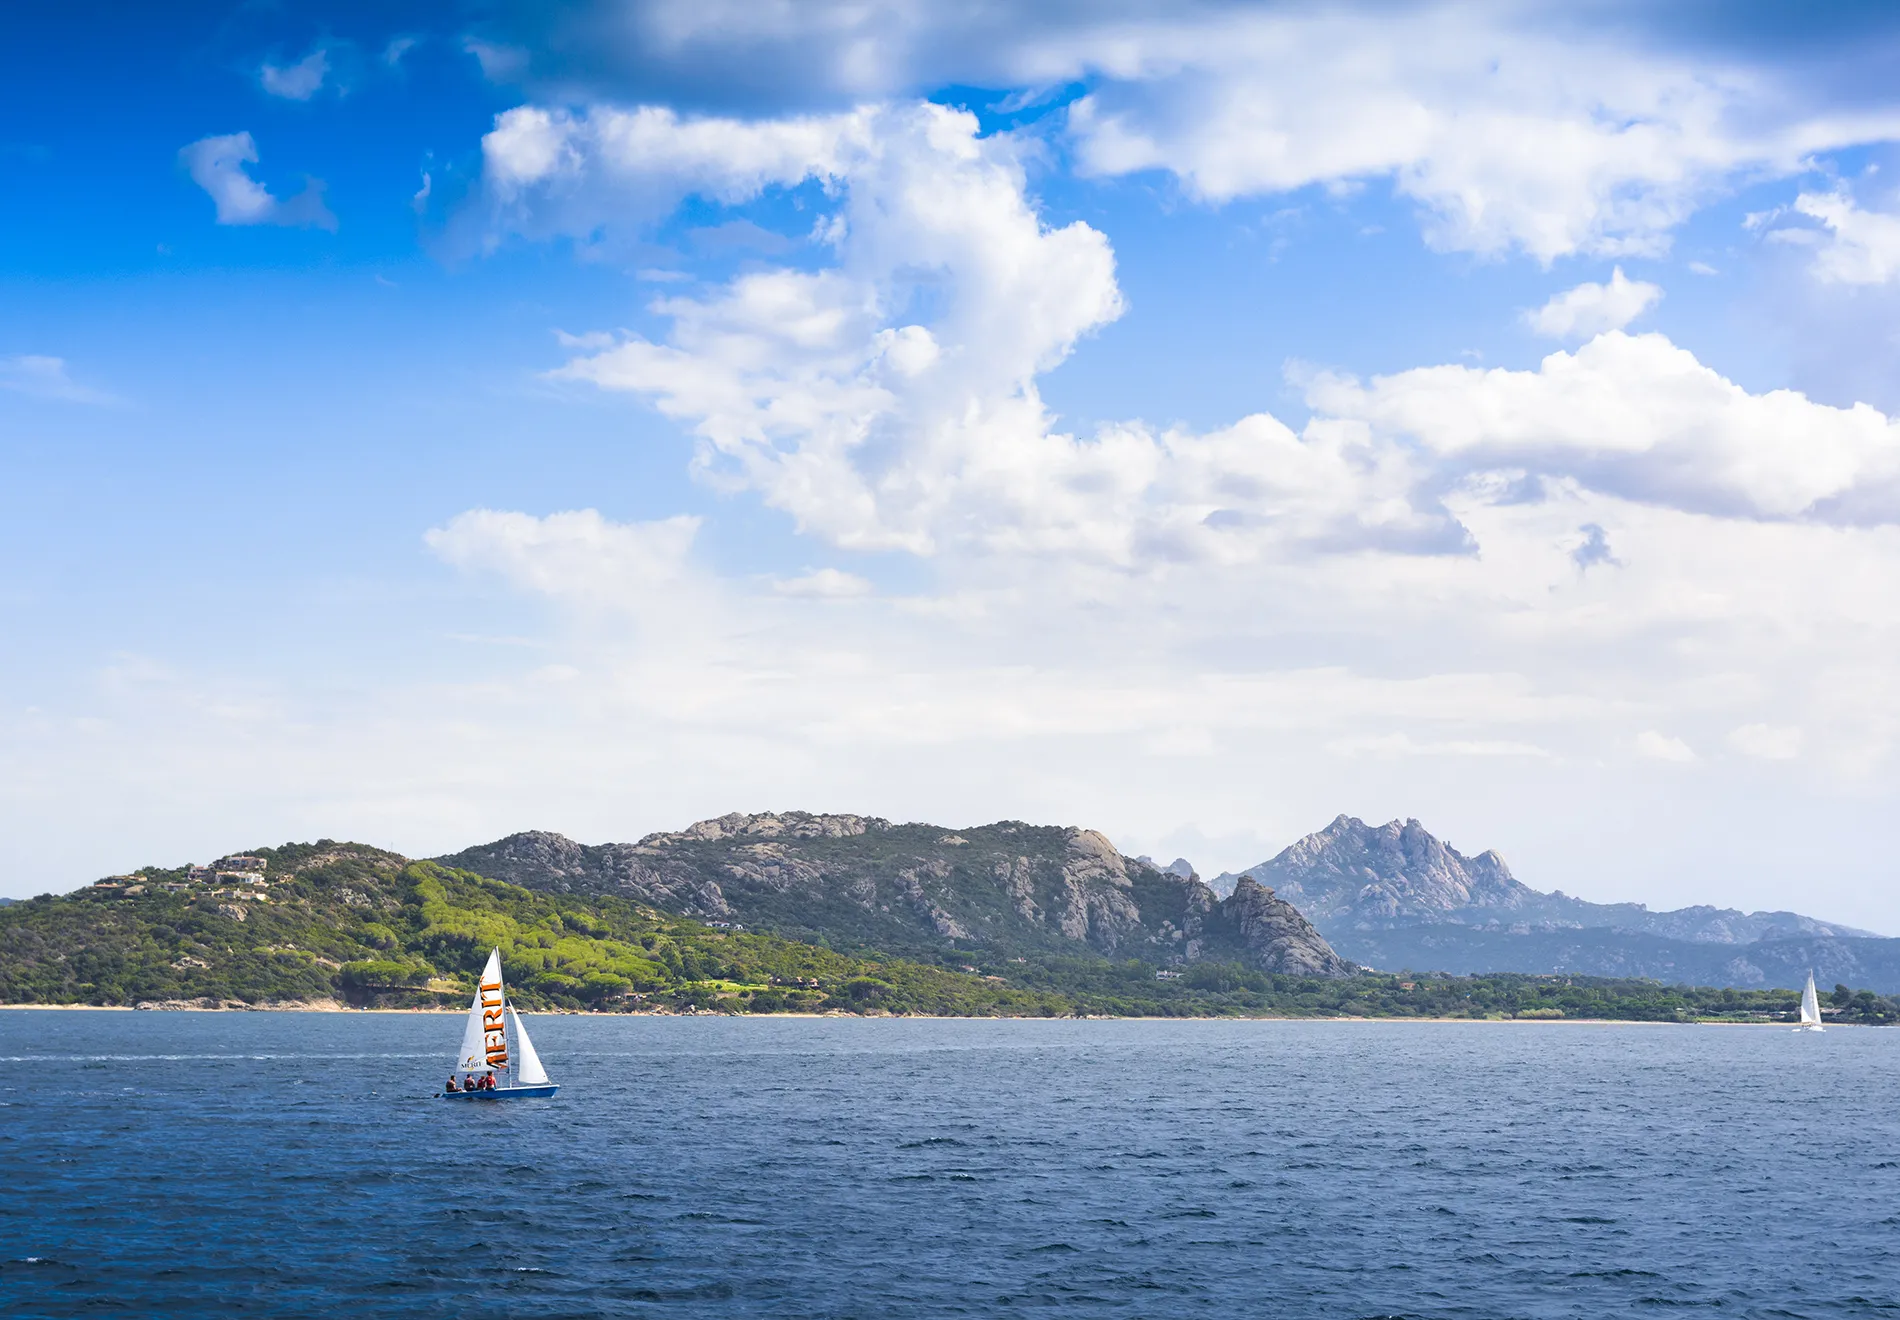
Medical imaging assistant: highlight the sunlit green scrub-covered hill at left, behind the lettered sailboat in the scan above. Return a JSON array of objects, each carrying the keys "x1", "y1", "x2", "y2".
[{"x1": 0, "y1": 841, "x2": 1068, "y2": 1014}]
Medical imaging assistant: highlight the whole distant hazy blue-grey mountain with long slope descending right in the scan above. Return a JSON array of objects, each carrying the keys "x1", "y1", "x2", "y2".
[{"x1": 1214, "y1": 815, "x2": 1900, "y2": 988}]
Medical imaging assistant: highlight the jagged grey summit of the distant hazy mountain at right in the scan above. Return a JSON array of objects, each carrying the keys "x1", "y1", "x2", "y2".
[{"x1": 1246, "y1": 815, "x2": 1539, "y2": 917}]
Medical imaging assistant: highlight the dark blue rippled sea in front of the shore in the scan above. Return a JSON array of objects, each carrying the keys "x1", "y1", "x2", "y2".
[{"x1": 0, "y1": 1010, "x2": 1900, "y2": 1320}]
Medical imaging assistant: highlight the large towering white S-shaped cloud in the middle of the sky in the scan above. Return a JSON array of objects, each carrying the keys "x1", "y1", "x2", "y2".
[{"x1": 513, "y1": 104, "x2": 1465, "y2": 566}]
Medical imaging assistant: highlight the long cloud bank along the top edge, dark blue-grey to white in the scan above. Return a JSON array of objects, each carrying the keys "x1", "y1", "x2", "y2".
[{"x1": 463, "y1": 0, "x2": 1900, "y2": 262}]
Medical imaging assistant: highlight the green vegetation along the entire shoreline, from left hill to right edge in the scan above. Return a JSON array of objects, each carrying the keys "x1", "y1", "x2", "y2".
[{"x1": 0, "y1": 841, "x2": 1900, "y2": 1024}]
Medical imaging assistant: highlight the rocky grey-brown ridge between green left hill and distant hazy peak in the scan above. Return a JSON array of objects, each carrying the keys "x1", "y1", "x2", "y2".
[{"x1": 439, "y1": 811, "x2": 1353, "y2": 976}]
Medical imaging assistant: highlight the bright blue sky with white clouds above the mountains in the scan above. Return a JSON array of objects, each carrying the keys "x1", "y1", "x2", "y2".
[{"x1": 0, "y1": 0, "x2": 1900, "y2": 934}]
